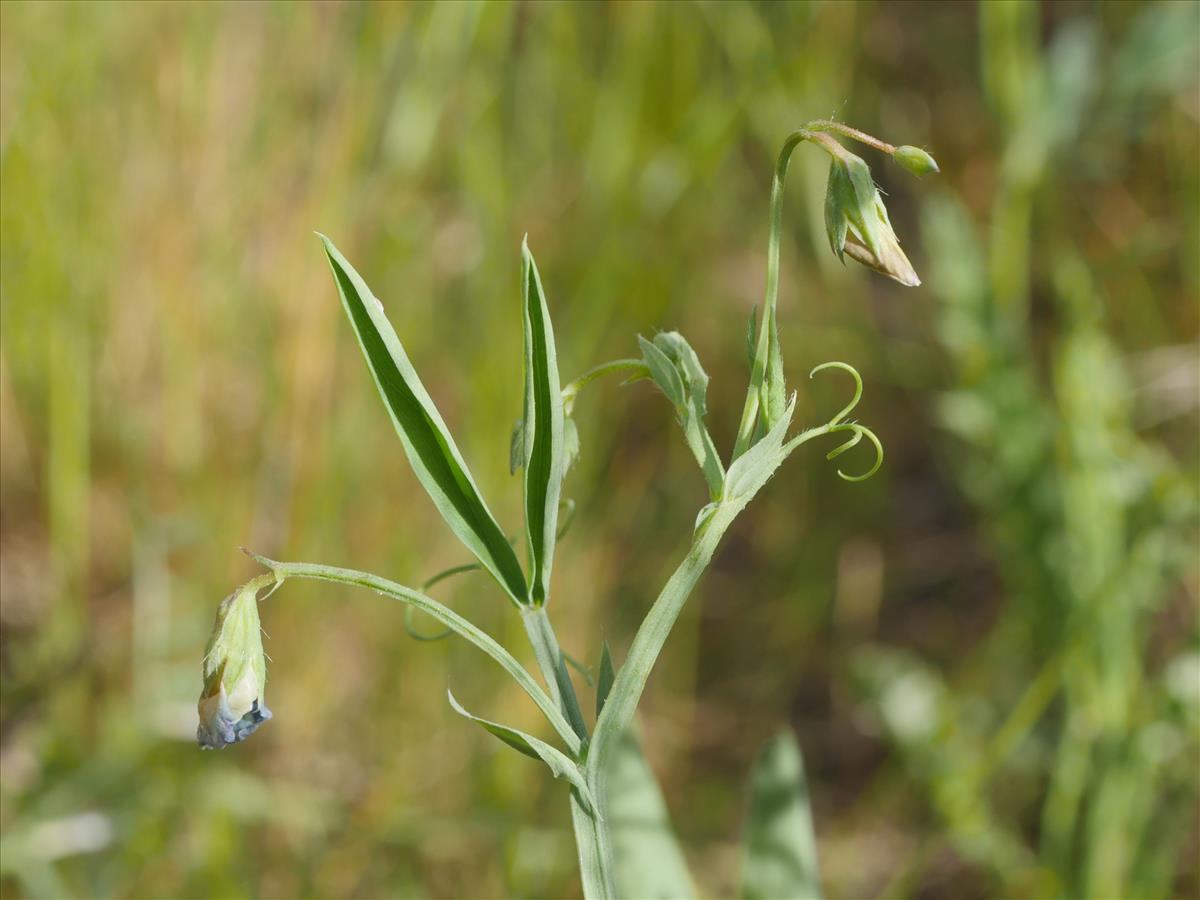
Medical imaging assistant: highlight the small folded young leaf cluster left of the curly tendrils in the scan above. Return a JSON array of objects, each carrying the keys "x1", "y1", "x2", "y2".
[{"x1": 637, "y1": 331, "x2": 725, "y2": 499}]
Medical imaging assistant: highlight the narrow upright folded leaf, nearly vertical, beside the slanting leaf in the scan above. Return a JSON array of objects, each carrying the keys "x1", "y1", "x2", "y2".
[{"x1": 521, "y1": 242, "x2": 565, "y2": 606}]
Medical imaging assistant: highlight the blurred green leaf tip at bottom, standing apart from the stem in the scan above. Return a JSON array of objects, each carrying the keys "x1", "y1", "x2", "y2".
[{"x1": 742, "y1": 732, "x2": 821, "y2": 900}]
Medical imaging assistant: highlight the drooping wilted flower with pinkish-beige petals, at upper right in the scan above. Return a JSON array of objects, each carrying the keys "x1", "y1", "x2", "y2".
[{"x1": 824, "y1": 146, "x2": 920, "y2": 287}]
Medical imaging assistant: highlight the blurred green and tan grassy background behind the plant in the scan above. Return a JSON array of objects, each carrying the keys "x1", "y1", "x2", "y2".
[{"x1": 0, "y1": 2, "x2": 1200, "y2": 898}]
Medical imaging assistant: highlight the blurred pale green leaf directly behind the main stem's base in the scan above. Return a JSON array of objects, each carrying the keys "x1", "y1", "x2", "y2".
[{"x1": 608, "y1": 731, "x2": 696, "y2": 900}]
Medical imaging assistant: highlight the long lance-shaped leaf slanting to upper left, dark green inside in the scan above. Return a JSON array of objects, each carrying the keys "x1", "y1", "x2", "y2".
[{"x1": 319, "y1": 235, "x2": 528, "y2": 605}]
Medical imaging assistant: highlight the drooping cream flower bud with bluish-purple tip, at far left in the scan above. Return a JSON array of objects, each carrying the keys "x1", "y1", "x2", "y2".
[{"x1": 196, "y1": 578, "x2": 271, "y2": 750}]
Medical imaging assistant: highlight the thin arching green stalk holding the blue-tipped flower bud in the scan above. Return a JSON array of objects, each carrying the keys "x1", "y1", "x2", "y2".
[{"x1": 254, "y1": 556, "x2": 583, "y2": 758}]
